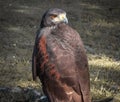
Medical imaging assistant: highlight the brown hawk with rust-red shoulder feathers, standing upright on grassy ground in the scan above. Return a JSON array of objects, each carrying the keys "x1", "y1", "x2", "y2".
[{"x1": 32, "y1": 8, "x2": 91, "y2": 102}]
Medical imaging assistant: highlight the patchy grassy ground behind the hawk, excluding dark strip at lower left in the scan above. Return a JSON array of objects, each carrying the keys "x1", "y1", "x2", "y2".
[{"x1": 0, "y1": 0, "x2": 120, "y2": 102}]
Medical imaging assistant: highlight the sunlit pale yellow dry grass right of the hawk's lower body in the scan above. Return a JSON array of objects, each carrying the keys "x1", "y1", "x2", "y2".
[{"x1": 89, "y1": 56, "x2": 120, "y2": 102}]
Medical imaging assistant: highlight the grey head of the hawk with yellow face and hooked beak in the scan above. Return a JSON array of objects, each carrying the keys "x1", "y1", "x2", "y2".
[{"x1": 40, "y1": 8, "x2": 68, "y2": 28}]
